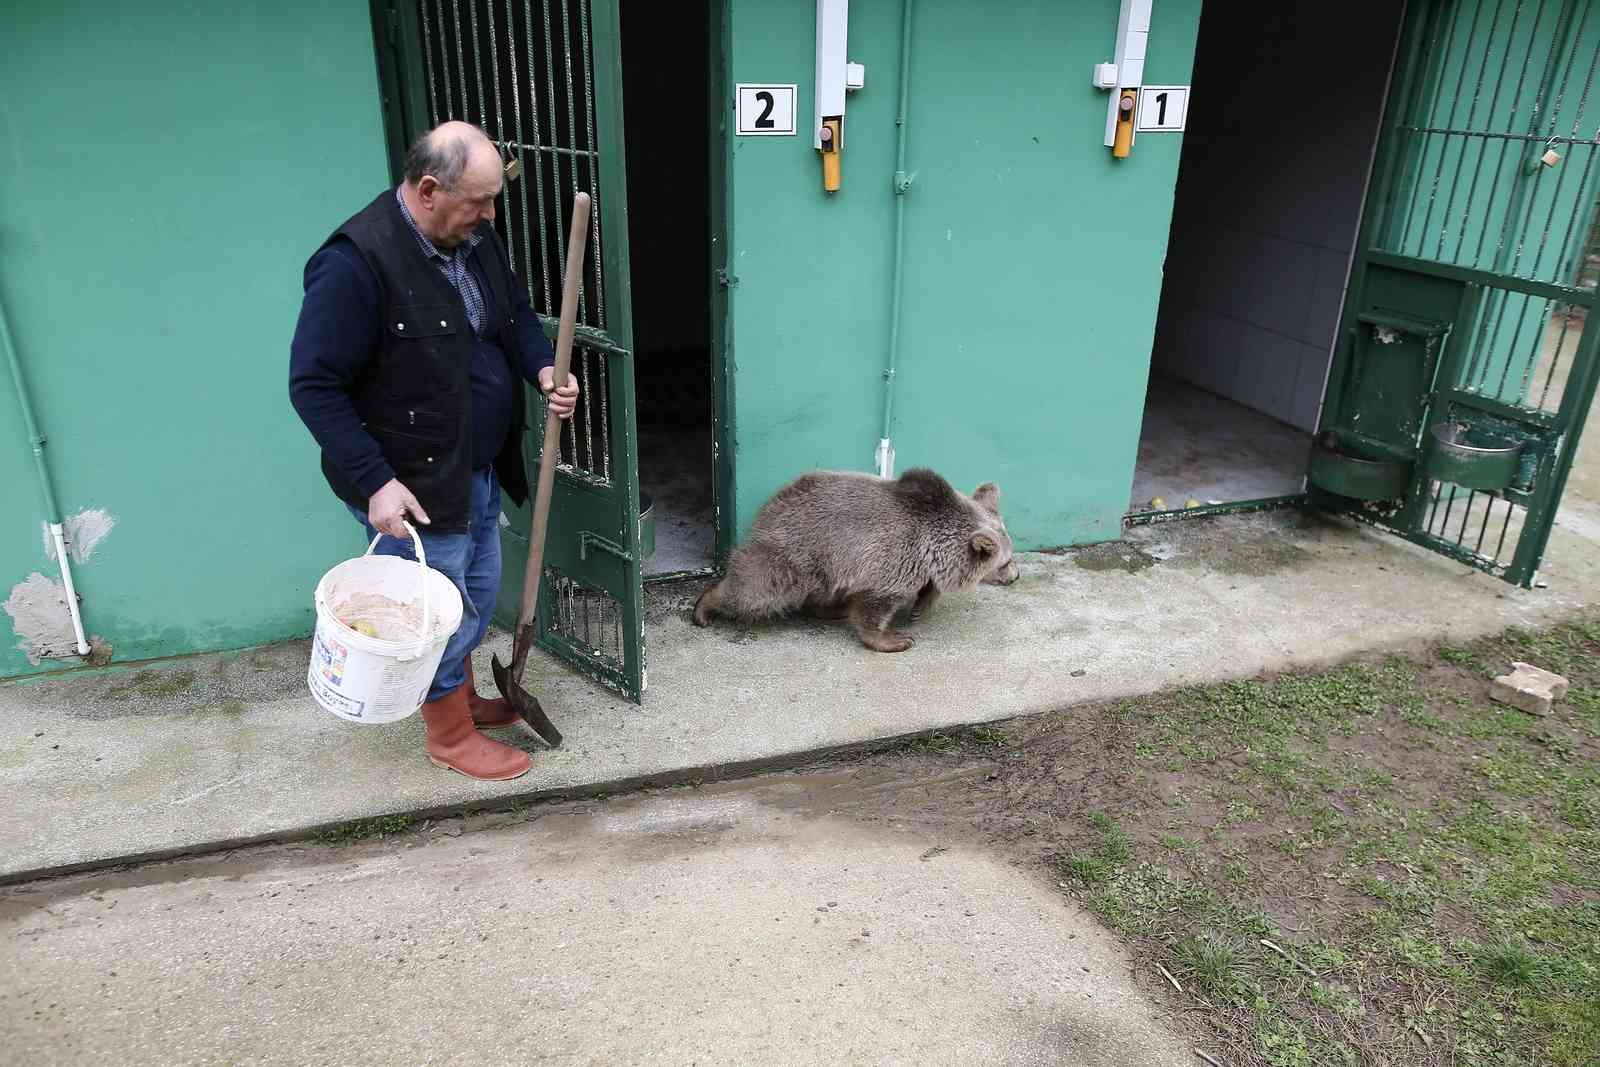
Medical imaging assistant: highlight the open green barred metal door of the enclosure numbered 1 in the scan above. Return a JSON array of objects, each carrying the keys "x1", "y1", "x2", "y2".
[{"x1": 1310, "y1": 0, "x2": 1600, "y2": 585}]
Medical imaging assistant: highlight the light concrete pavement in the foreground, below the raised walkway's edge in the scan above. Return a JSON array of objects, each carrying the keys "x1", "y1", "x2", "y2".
[{"x1": 0, "y1": 771, "x2": 1198, "y2": 1067}]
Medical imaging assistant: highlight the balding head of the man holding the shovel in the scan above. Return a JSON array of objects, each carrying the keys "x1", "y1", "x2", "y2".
[{"x1": 400, "y1": 122, "x2": 504, "y2": 248}]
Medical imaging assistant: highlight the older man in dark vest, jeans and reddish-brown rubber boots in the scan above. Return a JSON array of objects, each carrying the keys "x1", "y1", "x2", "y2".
[{"x1": 290, "y1": 122, "x2": 578, "y2": 781}]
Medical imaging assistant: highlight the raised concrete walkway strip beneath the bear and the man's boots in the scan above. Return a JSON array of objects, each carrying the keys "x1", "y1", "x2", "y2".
[{"x1": 0, "y1": 506, "x2": 1600, "y2": 880}]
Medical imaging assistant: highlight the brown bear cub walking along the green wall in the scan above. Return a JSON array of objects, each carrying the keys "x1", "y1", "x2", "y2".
[{"x1": 694, "y1": 469, "x2": 1018, "y2": 653}]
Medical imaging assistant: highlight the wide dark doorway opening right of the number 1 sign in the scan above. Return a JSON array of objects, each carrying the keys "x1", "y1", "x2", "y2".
[{"x1": 1128, "y1": 0, "x2": 1402, "y2": 515}]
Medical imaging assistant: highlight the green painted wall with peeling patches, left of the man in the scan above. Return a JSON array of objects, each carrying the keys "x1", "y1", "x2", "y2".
[{"x1": 0, "y1": 0, "x2": 387, "y2": 675}]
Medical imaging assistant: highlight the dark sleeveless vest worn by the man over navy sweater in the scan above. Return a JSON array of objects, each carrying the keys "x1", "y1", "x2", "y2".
[{"x1": 322, "y1": 189, "x2": 528, "y2": 533}]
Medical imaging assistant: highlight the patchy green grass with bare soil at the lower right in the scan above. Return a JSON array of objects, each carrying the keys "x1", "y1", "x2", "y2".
[{"x1": 1059, "y1": 621, "x2": 1600, "y2": 1067}]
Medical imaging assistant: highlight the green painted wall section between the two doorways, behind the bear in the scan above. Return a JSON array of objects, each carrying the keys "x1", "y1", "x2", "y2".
[{"x1": 730, "y1": 0, "x2": 1200, "y2": 547}]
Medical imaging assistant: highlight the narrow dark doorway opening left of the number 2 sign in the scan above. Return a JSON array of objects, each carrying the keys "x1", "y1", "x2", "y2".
[{"x1": 621, "y1": 0, "x2": 717, "y2": 579}]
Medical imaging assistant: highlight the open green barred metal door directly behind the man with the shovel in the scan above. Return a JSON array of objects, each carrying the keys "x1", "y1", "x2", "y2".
[{"x1": 374, "y1": 0, "x2": 645, "y2": 701}]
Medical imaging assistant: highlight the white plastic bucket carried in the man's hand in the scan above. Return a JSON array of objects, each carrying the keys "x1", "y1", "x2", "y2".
[{"x1": 306, "y1": 523, "x2": 461, "y2": 723}]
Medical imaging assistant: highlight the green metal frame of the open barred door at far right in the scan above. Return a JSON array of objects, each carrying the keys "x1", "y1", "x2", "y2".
[{"x1": 1309, "y1": 0, "x2": 1600, "y2": 587}]
